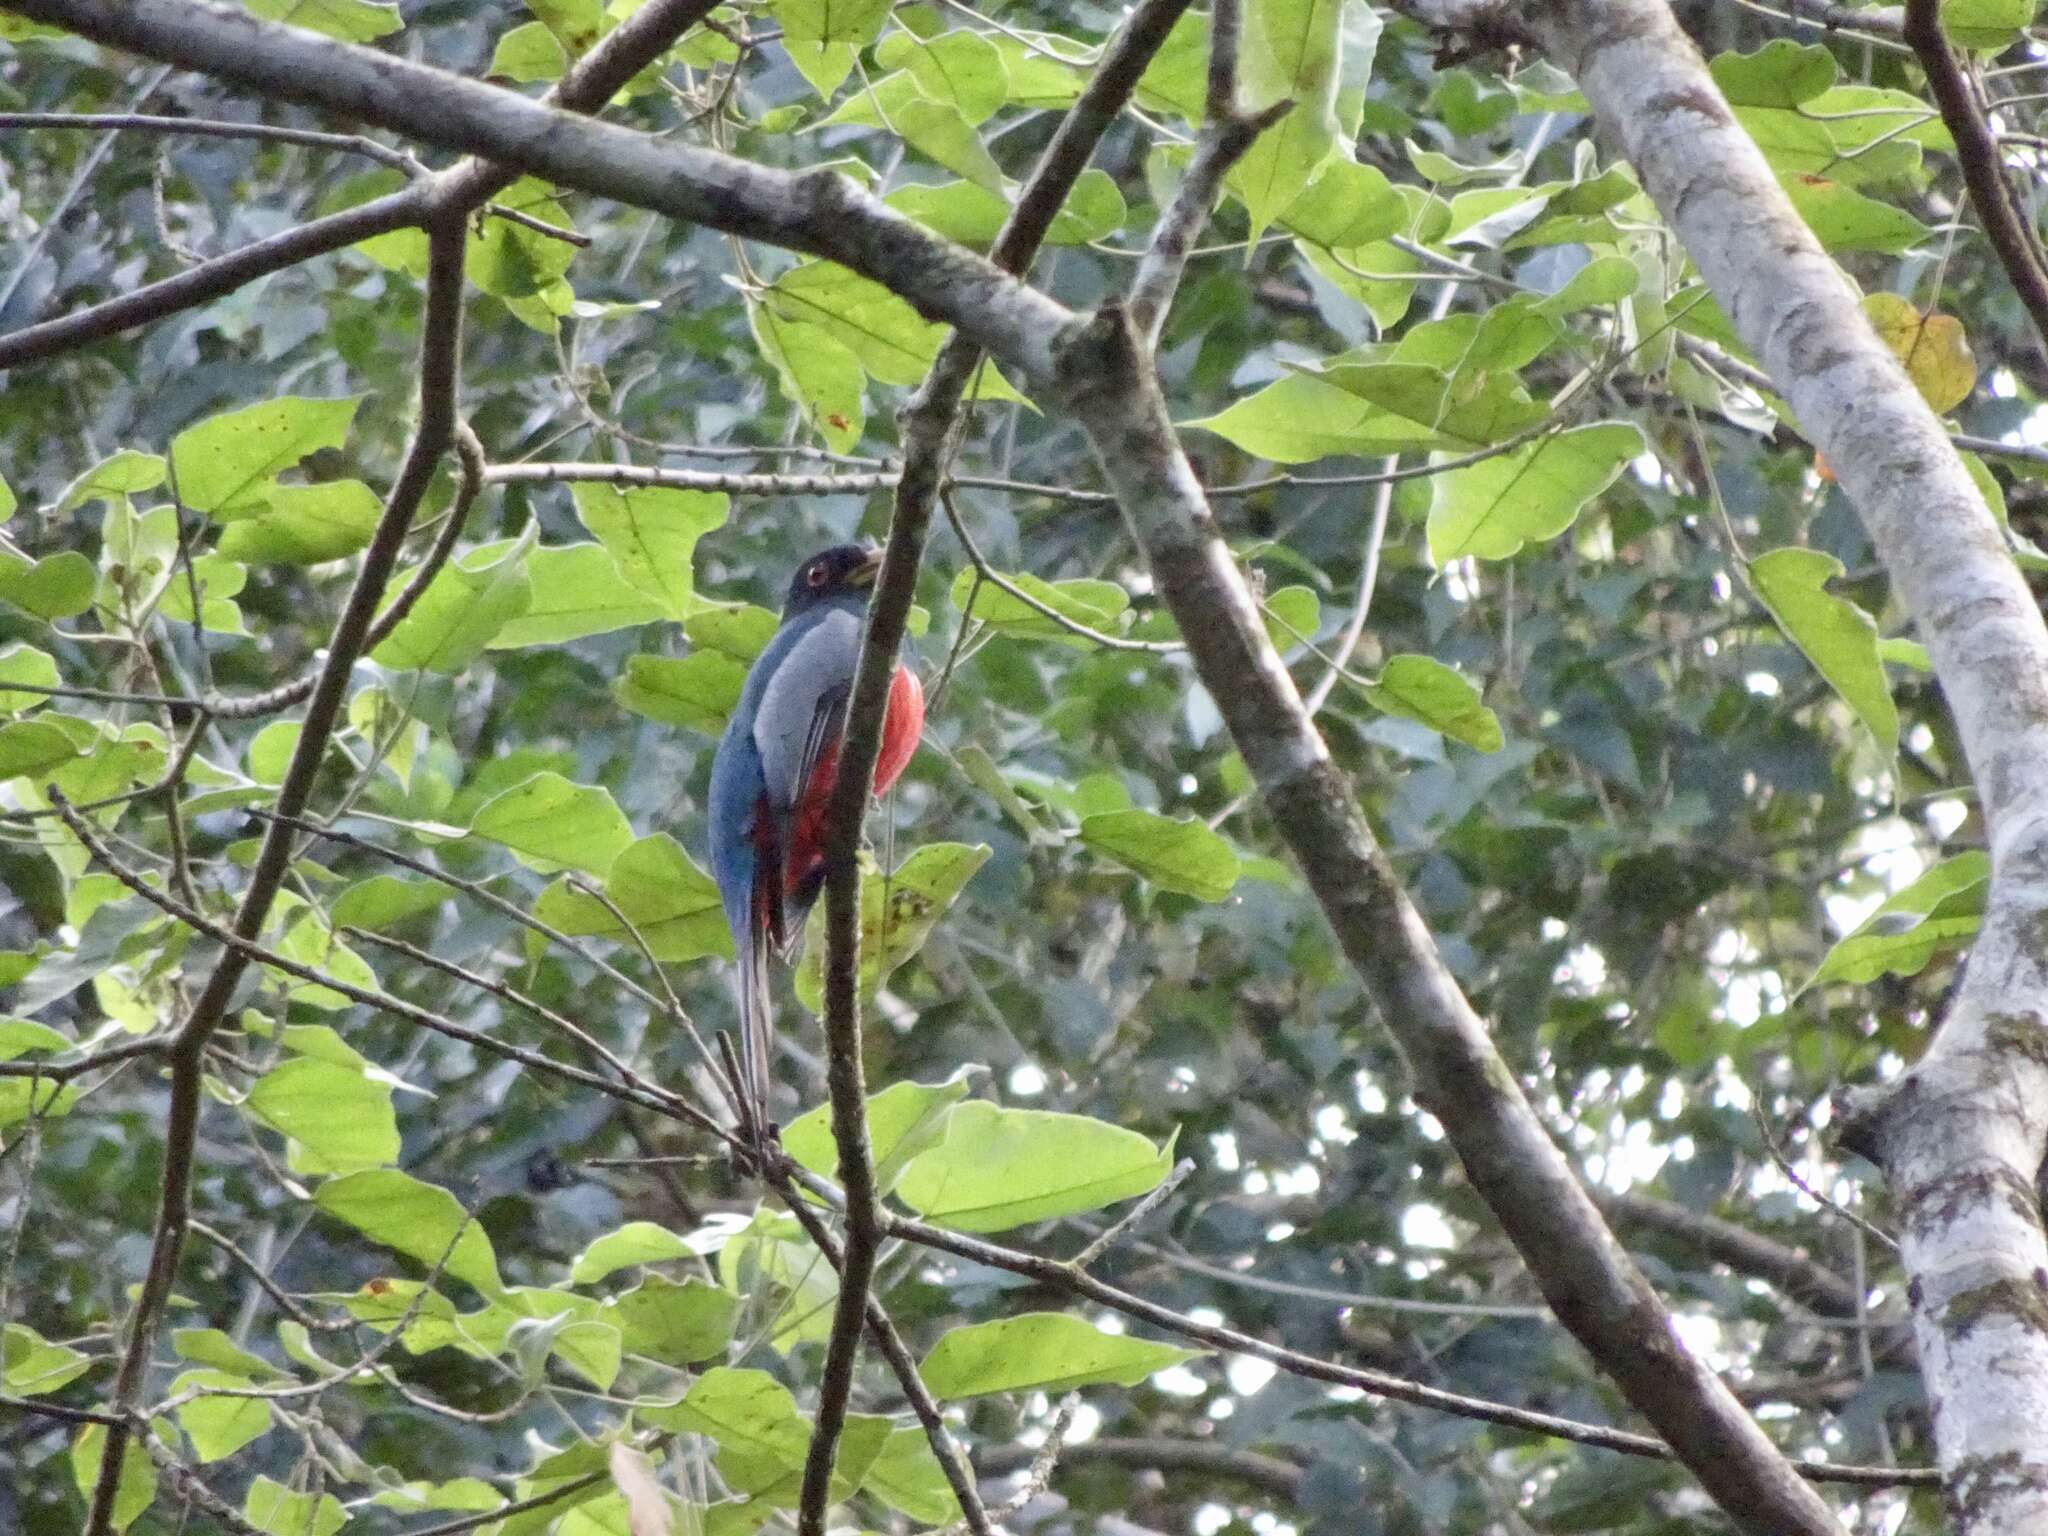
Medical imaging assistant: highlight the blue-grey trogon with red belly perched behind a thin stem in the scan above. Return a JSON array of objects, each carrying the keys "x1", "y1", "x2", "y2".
[{"x1": 711, "y1": 545, "x2": 924, "y2": 1135}]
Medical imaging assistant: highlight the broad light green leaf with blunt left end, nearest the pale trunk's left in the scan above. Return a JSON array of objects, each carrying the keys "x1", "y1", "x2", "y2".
[{"x1": 1430, "y1": 422, "x2": 1645, "y2": 565}]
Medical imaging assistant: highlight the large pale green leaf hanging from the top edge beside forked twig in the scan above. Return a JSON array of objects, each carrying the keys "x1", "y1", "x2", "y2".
[{"x1": 1229, "y1": 0, "x2": 1343, "y2": 240}]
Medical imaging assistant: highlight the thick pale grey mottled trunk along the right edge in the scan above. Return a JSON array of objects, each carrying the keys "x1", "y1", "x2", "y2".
[{"x1": 1409, "y1": 0, "x2": 2048, "y2": 1530}]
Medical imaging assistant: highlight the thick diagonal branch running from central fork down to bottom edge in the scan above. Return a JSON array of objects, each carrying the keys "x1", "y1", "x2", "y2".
[{"x1": 1059, "y1": 307, "x2": 1839, "y2": 1536}]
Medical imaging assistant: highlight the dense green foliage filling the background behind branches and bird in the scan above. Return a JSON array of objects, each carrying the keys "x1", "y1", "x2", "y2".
[{"x1": 0, "y1": 0, "x2": 2042, "y2": 1536}]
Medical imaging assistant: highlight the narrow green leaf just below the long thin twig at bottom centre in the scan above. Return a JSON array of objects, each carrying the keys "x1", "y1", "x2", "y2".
[{"x1": 918, "y1": 1313, "x2": 1202, "y2": 1401}]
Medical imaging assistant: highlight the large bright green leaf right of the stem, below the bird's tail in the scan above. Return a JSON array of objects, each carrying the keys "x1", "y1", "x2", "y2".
[{"x1": 897, "y1": 1100, "x2": 1174, "y2": 1233}]
